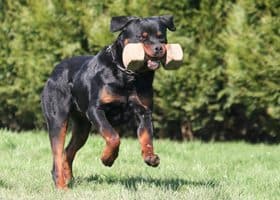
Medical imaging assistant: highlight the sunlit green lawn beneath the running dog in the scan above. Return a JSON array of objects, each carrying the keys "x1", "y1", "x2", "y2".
[{"x1": 0, "y1": 130, "x2": 280, "y2": 200}]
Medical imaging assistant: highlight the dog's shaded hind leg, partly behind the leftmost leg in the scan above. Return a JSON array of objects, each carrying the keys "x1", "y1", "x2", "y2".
[{"x1": 63, "y1": 115, "x2": 91, "y2": 184}]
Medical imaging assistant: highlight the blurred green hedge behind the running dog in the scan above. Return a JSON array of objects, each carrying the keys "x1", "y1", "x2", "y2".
[{"x1": 0, "y1": 0, "x2": 280, "y2": 142}]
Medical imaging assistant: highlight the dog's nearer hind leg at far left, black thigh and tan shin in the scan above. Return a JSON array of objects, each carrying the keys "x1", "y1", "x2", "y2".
[{"x1": 41, "y1": 80, "x2": 71, "y2": 189}]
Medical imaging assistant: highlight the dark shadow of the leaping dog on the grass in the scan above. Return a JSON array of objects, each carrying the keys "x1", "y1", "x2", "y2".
[{"x1": 72, "y1": 175, "x2": 218, "y2": 191}]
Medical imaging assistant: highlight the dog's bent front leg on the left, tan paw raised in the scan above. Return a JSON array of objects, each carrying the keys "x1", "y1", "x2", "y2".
[{"x1": 88, "y1": 107, "x2": 120, "y2": 167}]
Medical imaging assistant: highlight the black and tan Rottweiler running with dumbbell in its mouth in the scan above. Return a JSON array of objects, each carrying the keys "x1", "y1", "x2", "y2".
[{"x1": 41, "y1": 16, "x2": 175, "y2": 188}]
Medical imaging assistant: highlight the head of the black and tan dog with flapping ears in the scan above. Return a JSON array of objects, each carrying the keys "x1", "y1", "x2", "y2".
[{"x1": 111, "y1": 15, "x2": 176, "y2": 70}]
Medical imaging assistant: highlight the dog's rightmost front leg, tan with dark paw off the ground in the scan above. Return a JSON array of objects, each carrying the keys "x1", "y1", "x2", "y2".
[{"x1": 136, "y1": 109, "x2": 160, "y2": 167}]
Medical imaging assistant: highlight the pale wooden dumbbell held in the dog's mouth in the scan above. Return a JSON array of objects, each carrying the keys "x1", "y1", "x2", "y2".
[{"x1": 122, "y1": 43, "x2": 183, "y2": 71}]
